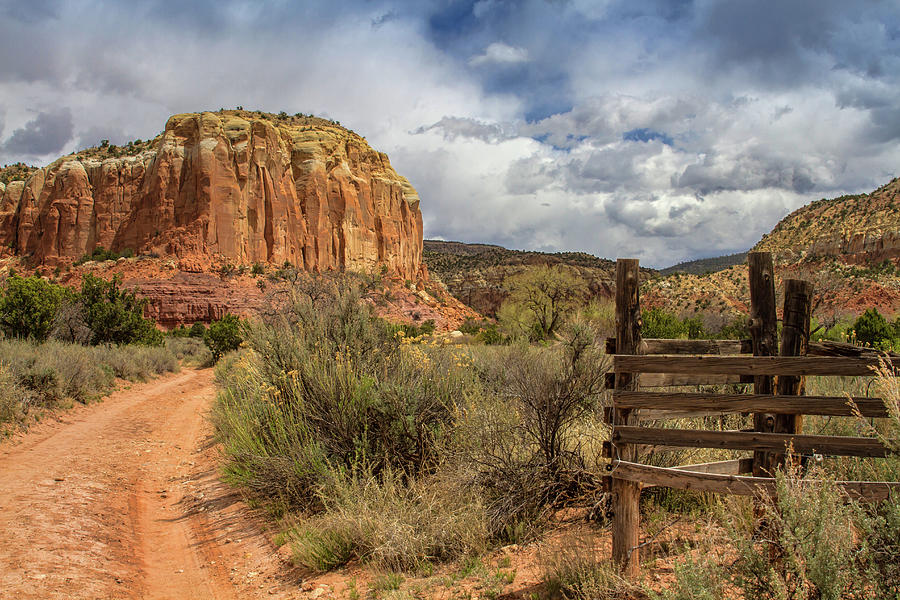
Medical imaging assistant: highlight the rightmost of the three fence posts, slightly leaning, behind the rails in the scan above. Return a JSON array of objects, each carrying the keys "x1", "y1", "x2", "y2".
[{"x1": 775, "y1": 279, "x2": 813, "y2": 466}]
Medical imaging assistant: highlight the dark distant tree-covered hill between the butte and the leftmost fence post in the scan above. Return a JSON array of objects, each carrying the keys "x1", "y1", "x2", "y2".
[{"x1": 422, "y1": 240, "x2": 656, "y2": 316}]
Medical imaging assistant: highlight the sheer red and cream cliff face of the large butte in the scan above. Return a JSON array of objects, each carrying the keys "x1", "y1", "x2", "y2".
[{"x1": 0, "y1": 111, "x2": 423, "y2": 279}]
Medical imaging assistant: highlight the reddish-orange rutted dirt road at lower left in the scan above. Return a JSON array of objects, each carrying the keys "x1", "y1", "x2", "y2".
[{"x1": 0, "y1": 369, "x2": 299, "y2": 599}]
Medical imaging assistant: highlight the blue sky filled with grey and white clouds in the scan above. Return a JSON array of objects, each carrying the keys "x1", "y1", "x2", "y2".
[{"x1": 0, "y1": 0, "x2": 900, "y2": 266}]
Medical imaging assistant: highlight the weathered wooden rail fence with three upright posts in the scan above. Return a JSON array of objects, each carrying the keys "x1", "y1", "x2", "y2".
[{"x1": 605, "y1": 252, "x2": 900, "y2": 575}]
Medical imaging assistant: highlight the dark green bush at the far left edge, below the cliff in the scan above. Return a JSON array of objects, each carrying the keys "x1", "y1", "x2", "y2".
[{"x1": 0, "y1": 275, "x2": 71, "y2": 341}]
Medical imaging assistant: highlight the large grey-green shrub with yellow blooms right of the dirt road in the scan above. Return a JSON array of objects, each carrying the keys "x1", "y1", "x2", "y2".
[{"x1": 216, "y1": 278, "x2": 475, "y2": 511}]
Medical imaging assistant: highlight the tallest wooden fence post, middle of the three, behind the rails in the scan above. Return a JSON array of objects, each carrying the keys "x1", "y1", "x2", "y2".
[{"x1": 747, "y1": 252, "x2": 778, "y2": 477}]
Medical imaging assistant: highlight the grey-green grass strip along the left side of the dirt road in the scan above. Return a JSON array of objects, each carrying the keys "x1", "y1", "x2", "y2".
[{"x1": 0, "y1": 340, "x2": 180, "y2": 434}]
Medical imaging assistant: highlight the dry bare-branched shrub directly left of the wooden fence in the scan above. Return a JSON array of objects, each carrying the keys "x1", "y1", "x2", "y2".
[{"x1": 457, "y1": 325, "x2": 608, "y2": 542}]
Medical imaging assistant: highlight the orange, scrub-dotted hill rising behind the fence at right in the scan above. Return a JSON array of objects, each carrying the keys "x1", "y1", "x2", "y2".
[{"x1": 641, "y1": 179, "x2": 900, "y2": 324}]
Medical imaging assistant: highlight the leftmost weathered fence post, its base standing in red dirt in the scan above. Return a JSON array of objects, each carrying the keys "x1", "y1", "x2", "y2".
[{"x1": 612, "y1": 258, "x2": 641, "y2": 576}]
